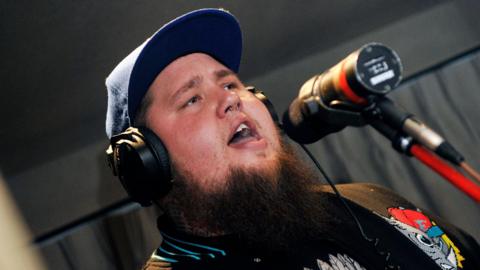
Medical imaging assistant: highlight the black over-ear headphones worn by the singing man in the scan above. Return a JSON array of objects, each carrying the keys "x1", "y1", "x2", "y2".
[{"x1": 106, "y1": 86, "x2": 281, "y2": 206}]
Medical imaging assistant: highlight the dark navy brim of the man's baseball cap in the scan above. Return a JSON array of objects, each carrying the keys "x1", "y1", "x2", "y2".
[{"x1": 128, "y1": 9, "x2": 242, "y2": 121}]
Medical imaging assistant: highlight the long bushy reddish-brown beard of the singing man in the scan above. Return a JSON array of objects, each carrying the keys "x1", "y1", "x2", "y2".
[{"x1": 160, "y1": 139, "x2": 335, "y2": 251}]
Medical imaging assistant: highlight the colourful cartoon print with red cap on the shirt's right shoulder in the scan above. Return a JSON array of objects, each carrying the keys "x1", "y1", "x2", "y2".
[{"x1": 383, "y1": 207, "x2": 465, "y2": 270}]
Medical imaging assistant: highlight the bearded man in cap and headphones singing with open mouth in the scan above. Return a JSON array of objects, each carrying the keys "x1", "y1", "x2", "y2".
[{"x1": 107, "y1": 9, "x2": 480, "y2": 269}]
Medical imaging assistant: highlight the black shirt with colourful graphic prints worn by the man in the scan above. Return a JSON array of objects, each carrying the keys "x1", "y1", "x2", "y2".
[{"x1": 147, "y1": 184, "x2": 480, "y2": 270}]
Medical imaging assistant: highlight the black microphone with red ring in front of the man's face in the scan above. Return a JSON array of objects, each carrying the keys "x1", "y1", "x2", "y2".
[{"x1": 283, "y1": 43, "x2": 403, "y2": 144}]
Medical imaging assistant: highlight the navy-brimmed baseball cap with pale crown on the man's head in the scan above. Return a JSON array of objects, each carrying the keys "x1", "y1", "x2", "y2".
[{"x1": 105, "y1": 8, "x2": 242, "y2": 138}]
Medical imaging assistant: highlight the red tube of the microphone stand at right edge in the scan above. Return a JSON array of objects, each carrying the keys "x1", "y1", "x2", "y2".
[{"x1": 410, "y1": 144, "x2": 480, "y2": 202}]
